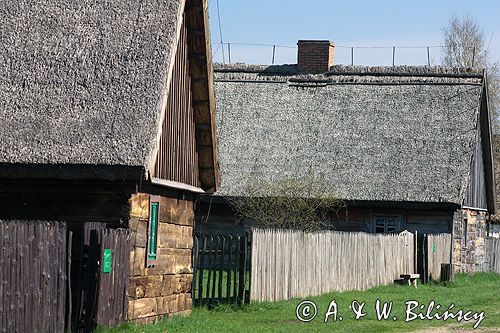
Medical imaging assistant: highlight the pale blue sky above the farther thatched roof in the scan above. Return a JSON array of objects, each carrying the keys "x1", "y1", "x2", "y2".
[{"x1": 209, "y1": 0, "x2": 500, "y2": 65}]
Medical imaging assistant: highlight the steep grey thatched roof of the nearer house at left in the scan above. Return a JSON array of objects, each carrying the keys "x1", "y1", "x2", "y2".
[{"x1": 0, "y1": 0, "x2": 184, "y2": 179}]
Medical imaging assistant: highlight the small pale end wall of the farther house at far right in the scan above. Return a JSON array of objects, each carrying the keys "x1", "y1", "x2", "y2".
[{"x1": 453, "y1": 209, "x2": 487, "y2": 272}]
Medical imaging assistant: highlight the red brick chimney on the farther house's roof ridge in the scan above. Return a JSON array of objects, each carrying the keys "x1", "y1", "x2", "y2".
[{"x1": 297, "y1": 40, "x2": 335, "y2": 73}]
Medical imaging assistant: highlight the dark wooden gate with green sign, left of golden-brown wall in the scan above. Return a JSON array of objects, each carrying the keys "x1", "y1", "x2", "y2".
[{"x1": 76, "y1": 222, "x2": 130, "y2": 333}]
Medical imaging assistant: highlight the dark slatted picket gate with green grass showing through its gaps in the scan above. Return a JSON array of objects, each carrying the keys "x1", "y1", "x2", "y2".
[{"x1": 192, "y1": 234, "x2": 250, "y2": 307}]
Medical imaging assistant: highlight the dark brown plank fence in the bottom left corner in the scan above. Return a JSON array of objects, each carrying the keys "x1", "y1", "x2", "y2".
[{"x1": 0, "y1": 221, "x2": 69, "y2": 333}]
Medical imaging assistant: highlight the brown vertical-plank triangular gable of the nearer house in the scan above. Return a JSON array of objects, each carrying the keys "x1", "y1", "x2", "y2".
[{"x1": 153, "y1": 17, "x2": 201, "y2": 187}]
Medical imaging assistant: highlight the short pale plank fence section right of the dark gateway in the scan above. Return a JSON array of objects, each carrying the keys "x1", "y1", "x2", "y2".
[{"x1": 427, "y1": 234, "x2": 451, "y2": 280}]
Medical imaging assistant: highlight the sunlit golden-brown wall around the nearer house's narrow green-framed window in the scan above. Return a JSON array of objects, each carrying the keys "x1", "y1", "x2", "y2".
[{"x1": 128, "y1": 193, "x2": 194, "y2": 323}]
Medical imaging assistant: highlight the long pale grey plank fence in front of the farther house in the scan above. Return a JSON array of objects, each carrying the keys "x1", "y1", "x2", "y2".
[{"x1": 250, "y1": 229, "x2": 415, "y2": 301}]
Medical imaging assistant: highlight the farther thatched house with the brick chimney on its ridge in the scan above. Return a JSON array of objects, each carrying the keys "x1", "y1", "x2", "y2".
[{"x1": 196, "y1": 41, "x2": 496, "y2": 271}]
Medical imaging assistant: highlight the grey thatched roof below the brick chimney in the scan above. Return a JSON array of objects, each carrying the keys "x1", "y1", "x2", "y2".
[{"x1": 215, "y1": 64, "x2": 490, "y2": 205}]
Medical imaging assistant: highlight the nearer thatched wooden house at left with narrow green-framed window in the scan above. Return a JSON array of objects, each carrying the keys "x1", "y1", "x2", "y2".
[{"x1": 0, "y1": 0, "x2": 219, "y2": 332}]
